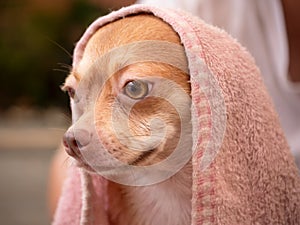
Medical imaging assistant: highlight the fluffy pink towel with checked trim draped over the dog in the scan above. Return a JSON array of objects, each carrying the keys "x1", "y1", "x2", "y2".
[{"x1": 53, "y1": 5, "x2": 300, "y2": 225}]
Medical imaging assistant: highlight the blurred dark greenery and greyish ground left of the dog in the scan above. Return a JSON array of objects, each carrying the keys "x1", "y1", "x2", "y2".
[{"x1": 0, "y1": 0, "x2": 108, "y2": 225}]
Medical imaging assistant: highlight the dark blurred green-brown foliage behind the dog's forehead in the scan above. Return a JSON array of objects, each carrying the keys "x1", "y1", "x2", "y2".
[{"x1": 0, "y1": 0, "x2": 106, "y2": 111}]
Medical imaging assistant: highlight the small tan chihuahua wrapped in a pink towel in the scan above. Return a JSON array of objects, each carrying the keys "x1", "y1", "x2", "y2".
[{"x1": 63, "y1": 14, "x2": 192, "y2": 225}]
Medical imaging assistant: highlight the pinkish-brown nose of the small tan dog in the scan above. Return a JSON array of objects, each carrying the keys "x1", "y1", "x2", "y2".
[{"x1": 63, "y1": 129, "x2": 90, "y2": 157}]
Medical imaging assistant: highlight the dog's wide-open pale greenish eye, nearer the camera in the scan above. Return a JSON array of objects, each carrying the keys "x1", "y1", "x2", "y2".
[{"x1": 124, "y1": 80, "x2": 149, "y2": 99}]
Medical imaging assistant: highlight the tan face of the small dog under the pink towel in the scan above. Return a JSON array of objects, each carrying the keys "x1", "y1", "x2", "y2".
[{"x1": 63, "y1": 15, "x2": 191, "y2": 179}]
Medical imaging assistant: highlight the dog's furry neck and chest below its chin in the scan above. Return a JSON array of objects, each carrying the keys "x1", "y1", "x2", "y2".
[{"x1": 108, "y1": 162, "x2": 192, "y2": 225}]
